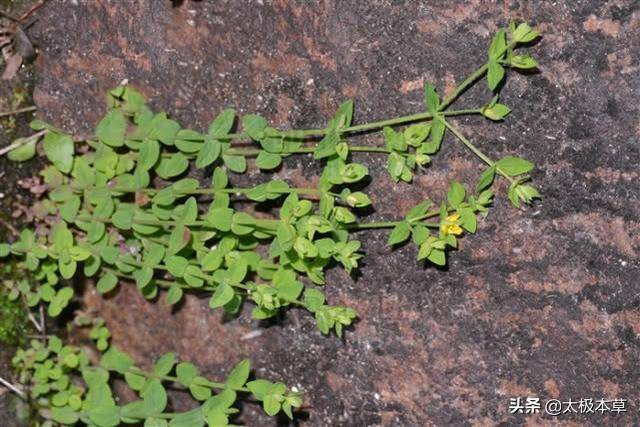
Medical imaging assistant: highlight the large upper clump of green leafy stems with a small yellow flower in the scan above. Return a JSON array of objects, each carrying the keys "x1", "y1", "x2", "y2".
[{"x1": 0, "y1": 19, "x2": 539, "y2": 424}]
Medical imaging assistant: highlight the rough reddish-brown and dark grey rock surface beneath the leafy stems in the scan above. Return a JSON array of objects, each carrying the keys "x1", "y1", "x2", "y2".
[{"x1": 0, "y1": 0, "x2": 640, "y2": 426}]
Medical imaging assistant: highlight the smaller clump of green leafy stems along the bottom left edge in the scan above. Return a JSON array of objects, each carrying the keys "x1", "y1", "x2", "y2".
[{"x1": 12, "y1": 322, "x2": 302, "y2": 427}]
